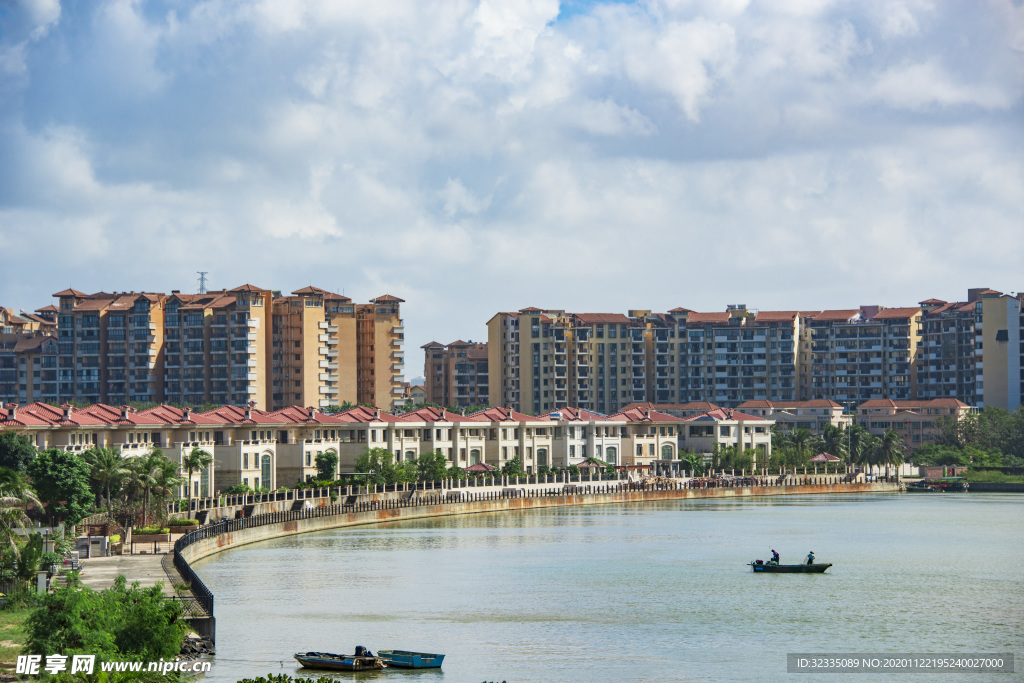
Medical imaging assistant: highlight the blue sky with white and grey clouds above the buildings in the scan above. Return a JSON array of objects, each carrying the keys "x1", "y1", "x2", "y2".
[{"x1": 0, "y1": 0, "x2": 1024, "y2": 377}]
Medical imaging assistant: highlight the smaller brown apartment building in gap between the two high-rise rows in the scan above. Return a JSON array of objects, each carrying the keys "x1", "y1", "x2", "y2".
[{"x1": 422, "y1": 340, "x2": 488, "y2": 408}]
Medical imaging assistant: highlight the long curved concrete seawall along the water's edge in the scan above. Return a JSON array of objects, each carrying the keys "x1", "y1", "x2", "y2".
[{"x1": 180, "y1": 481, "x2": 900, "y2": 564}]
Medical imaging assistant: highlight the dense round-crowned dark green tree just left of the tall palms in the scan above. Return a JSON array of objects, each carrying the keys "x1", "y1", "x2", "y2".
[{"x1": 28, "y1": 449, "x2": 93, "y2": 525}]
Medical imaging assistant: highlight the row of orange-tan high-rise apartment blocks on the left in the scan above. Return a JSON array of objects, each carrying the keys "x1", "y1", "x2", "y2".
[{"x1": 0, "y1": 285, "x2": 404, "y2": 410}]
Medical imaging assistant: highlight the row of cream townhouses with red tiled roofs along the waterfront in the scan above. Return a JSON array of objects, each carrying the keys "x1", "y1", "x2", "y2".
[{"x1": 0, "y1": 402, "x2": 773, "y2": 496}]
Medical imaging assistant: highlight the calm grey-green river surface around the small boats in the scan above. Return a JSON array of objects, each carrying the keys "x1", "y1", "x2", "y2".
[{"x1": 196, "y1": 494, "x2": 1024, "y2": 683}]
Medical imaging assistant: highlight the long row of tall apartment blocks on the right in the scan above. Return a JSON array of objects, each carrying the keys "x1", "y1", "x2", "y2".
[{"x1": 481, "y1": 289, "x2": 1024, "y2": 413}]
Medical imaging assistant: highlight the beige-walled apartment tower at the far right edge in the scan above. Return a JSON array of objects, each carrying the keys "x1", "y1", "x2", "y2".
[{"x1": 975, "y1": 290, "x2": 1024, "y2": 411}]
